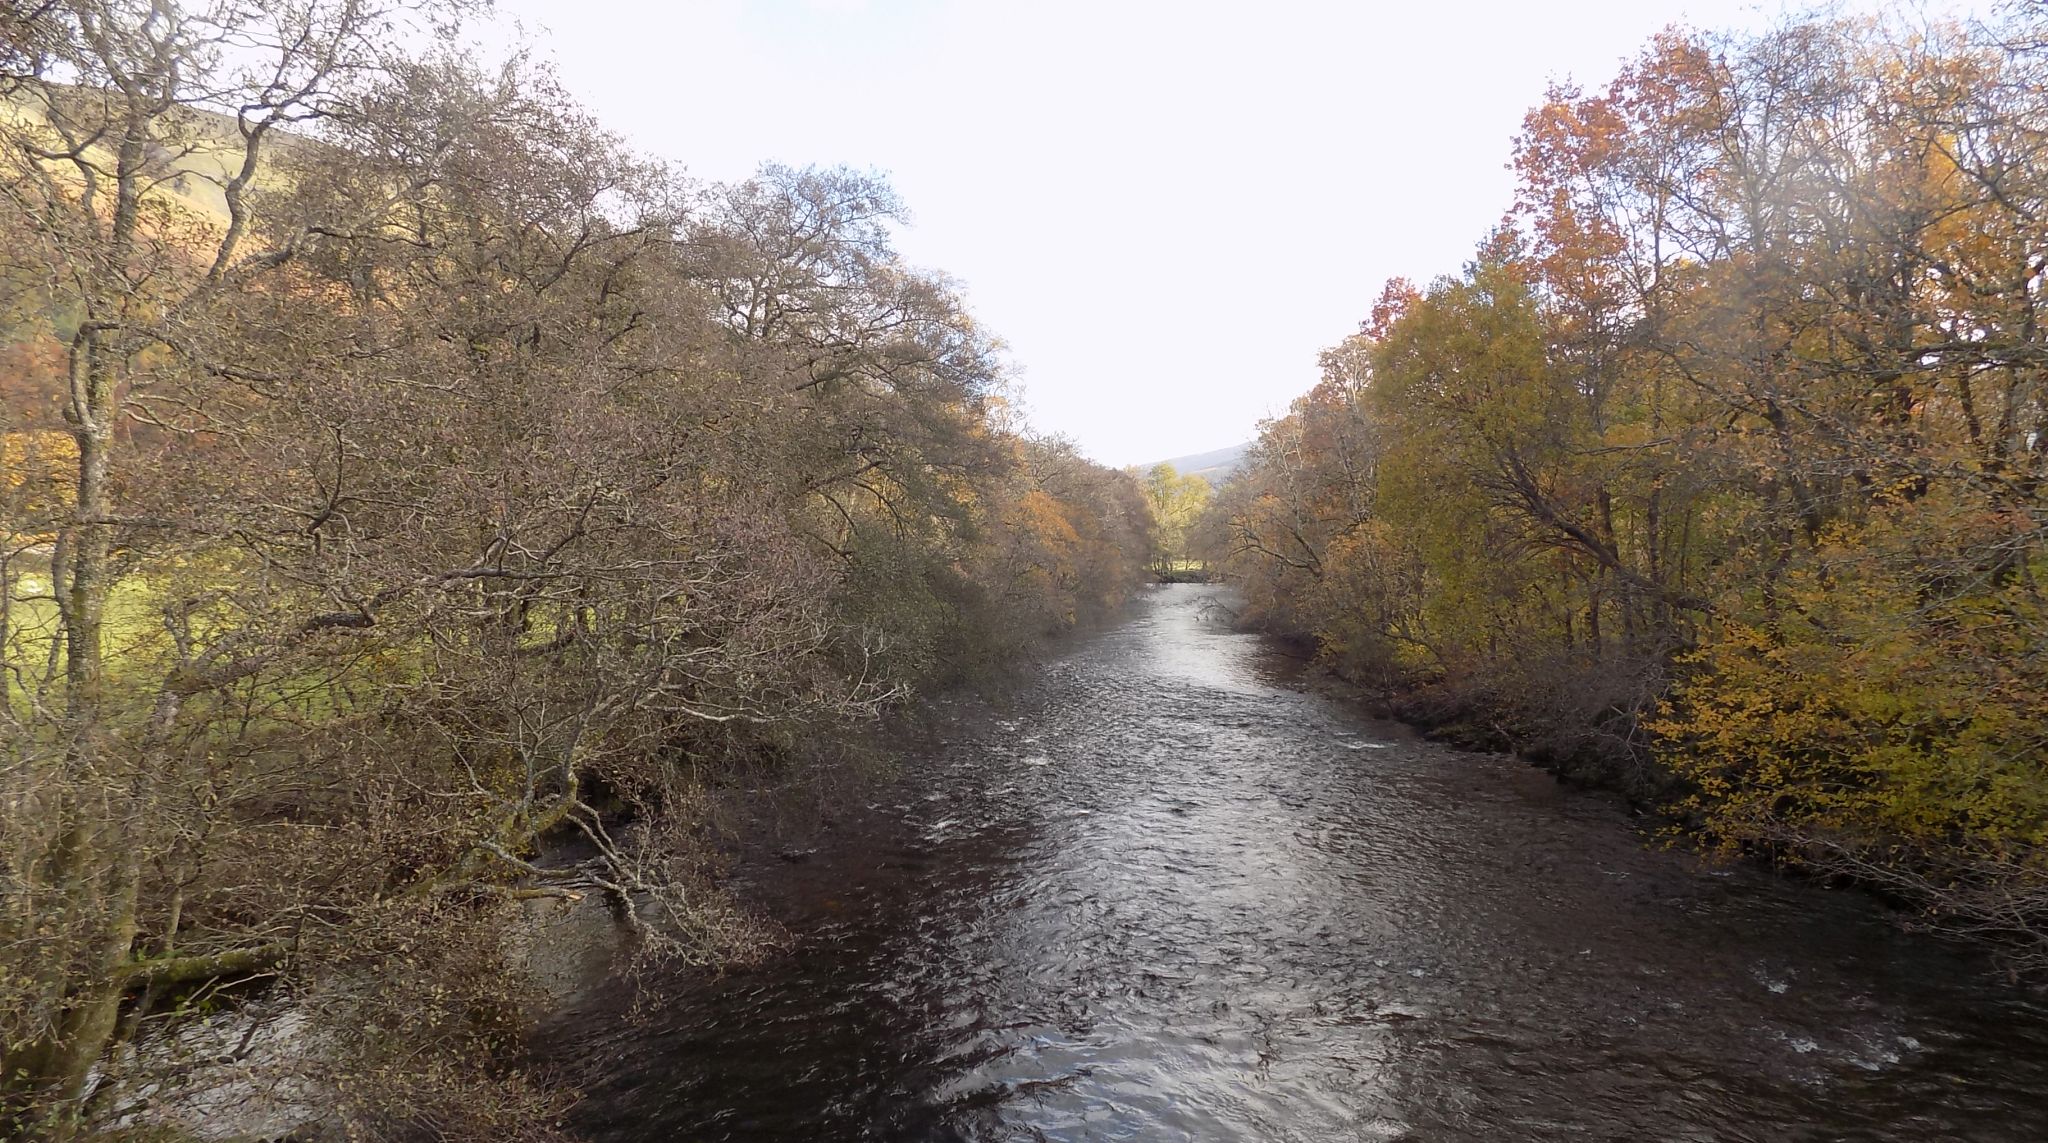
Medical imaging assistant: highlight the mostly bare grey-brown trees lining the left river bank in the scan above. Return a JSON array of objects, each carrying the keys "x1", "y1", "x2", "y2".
[{"x1": 0, "y1": 0, "x2": 1153, "y2": 1139}]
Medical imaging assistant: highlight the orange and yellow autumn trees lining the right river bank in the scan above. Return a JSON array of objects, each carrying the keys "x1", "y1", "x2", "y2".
[{"x1": 1204, "y1": 6, "x2": 2048, "y2": 963}]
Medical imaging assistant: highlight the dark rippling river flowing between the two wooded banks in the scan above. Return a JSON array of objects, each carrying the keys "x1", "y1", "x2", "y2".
[{"x1": 555, "y1": 586, "x2": 2048, "y2": 1143}]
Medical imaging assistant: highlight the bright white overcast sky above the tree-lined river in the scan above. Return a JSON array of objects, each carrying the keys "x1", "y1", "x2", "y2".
[{"x1": 494, "y1": 0, "x2": 1990, "y2": 465}]
